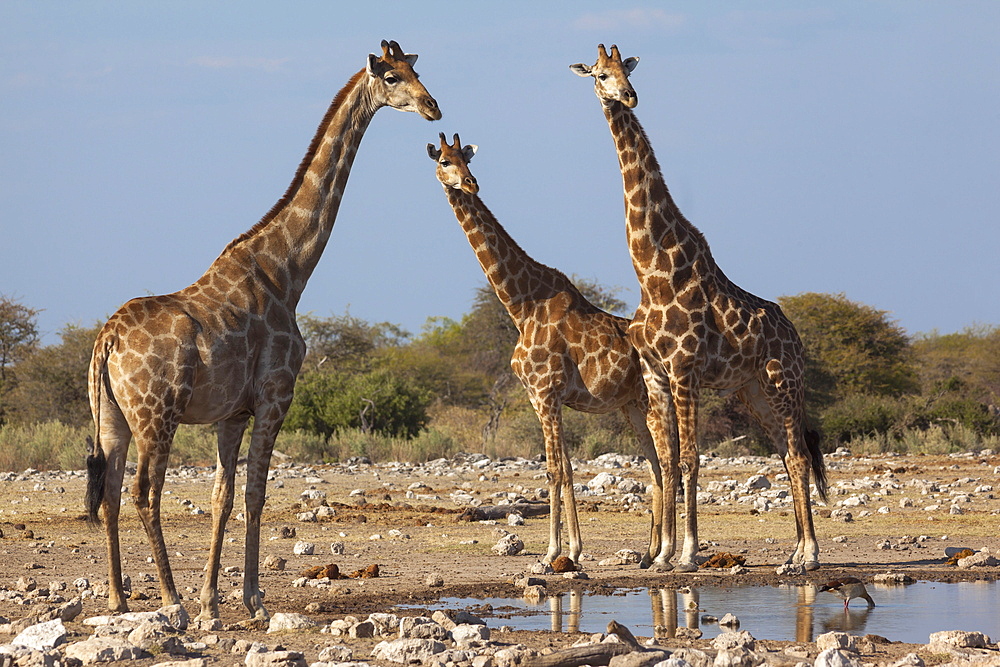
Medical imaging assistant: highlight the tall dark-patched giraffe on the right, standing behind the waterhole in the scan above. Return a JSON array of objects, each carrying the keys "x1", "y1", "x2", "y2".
[{"x1": 570, "y1": 44, "x2": 826, "y2": 572}]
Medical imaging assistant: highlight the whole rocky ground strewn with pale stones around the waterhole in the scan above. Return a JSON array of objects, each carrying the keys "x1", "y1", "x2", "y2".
[{"x1": 0, "y1": 450, "x2": 1000, "y2": 667}]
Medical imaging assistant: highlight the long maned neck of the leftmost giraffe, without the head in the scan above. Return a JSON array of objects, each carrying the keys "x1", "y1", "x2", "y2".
[{"x1": 202, "y1": 70, "x2": 381, "y2": 312}]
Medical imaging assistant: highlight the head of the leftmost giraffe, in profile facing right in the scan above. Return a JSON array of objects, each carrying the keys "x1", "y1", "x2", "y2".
[{"x1": 366, "y1": 40, "x2": 441, "y2": 120}]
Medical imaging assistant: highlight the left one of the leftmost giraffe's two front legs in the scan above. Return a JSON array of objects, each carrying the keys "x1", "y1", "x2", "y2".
[{"x1": 196, "y1": 419, "x2": 247, "y2": 621}]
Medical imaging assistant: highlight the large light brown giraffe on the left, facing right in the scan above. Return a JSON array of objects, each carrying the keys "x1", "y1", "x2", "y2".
[{"x1": 86, "y1": 41, "x2": 441, "y2": 620}]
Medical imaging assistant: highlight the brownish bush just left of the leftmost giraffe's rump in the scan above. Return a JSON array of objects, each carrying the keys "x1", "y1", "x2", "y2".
[{"x1": 9, "y1": 324, "x2": 100, "y2": 426}]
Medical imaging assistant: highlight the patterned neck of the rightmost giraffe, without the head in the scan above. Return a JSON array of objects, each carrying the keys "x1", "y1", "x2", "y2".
[{"x1": 603, "y1": 100, "x2": 715, "y2": 296}]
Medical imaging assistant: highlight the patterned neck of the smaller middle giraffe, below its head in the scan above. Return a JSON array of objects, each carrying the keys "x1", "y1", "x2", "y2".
[{"x1": 446, "y1": 188, "x2": 578, "y2": 330}]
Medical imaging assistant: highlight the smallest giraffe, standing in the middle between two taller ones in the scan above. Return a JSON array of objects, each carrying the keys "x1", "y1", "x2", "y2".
[{"x1": 427, "y1": 133, "x2": 665, "y2": 567}]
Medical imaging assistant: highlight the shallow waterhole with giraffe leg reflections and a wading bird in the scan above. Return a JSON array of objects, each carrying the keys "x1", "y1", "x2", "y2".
[{"x1": 416, "y1": 582, "x2": 1000, "y2": 644}]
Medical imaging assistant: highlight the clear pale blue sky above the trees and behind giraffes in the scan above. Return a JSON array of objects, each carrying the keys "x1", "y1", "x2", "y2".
[{"x1": 0, "y1": 0, "x2": 1000, "y2": 343}]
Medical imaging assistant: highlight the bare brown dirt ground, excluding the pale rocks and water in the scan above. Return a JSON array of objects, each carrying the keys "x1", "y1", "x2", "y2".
[{"x1": 0, "y1": 448, "x2": 1000, "y2": 664}]
